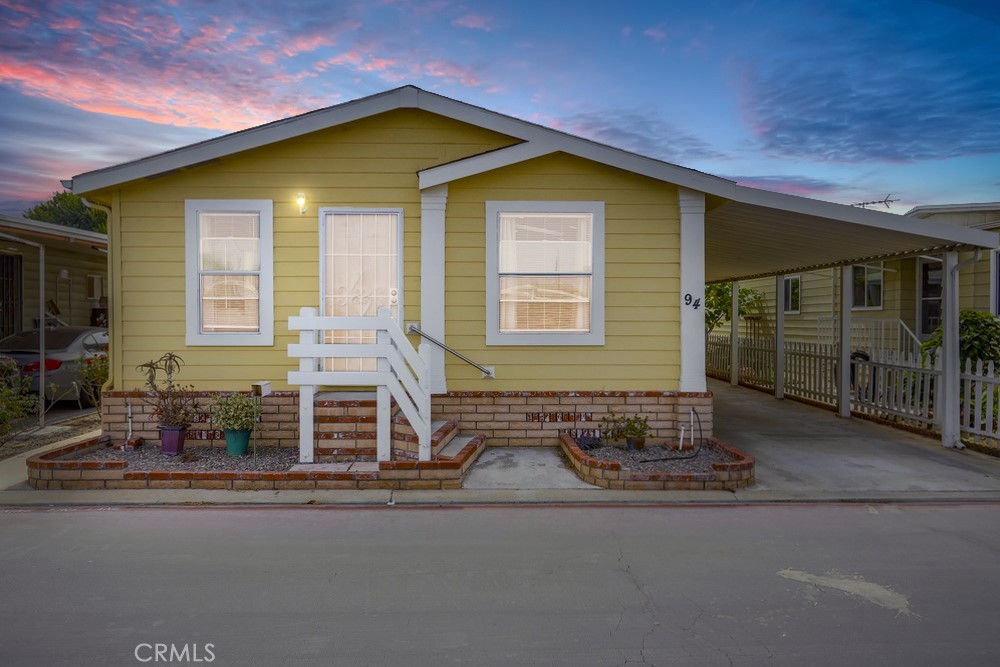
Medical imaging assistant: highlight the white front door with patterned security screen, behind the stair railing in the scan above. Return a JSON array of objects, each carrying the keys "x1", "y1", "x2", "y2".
[{"x1": 321, "y1": 209, "x2": 403, "y2": 371}]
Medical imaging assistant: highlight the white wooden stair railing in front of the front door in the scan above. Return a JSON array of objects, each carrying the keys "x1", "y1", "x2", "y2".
[{"x1": 288, "y1": 308, "x2": 431, "y2": 463}]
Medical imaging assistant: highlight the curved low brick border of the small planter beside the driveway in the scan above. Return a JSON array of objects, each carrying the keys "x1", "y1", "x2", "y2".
[{"x1": 559, "y1": 434, "x2": 755, "y2": 491}]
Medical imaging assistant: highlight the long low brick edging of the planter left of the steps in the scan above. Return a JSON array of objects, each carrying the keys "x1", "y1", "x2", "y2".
[{"x1": 27, "y1": 435, "x2": 486, "y2": 491}]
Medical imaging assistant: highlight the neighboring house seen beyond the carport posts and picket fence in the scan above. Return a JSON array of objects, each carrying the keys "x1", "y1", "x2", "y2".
[{"x1": 719, "y1": 202, "x2": 1000, "y2": 360}]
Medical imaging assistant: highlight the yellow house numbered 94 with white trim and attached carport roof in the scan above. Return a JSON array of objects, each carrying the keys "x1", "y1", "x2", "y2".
[{"x1": 64, "y1": 86, "x2": 996, "y2": 460}]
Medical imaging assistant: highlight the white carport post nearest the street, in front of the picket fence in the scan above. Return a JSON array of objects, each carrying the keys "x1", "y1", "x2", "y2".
[{"x1": 937, "y1": 252, "x2": 964, "y2": 449}]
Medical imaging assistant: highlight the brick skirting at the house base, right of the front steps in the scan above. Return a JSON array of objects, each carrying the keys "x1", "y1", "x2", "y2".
[{"x1": 432, "y1": 391, "x2": 712, "y2": 447}]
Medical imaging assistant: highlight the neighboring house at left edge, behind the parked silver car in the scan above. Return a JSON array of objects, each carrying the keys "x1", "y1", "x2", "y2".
[{"x1": 0, "y1": 214, "x2": 108, "y2": 338}]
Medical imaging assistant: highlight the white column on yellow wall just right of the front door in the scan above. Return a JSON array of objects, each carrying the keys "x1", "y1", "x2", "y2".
[{"x1": 420, "y1": 183, "x2": 448, "y2": 394}]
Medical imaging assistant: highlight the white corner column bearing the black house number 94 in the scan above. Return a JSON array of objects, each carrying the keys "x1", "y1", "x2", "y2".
[{"x1": 678, "y1": 188, "x2": 708, "y2": 392}]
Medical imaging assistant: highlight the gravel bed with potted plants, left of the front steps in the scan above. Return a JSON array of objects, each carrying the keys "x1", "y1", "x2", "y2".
[{"x1": 64, "y1": 445, "x2": 299, "y2": 472}]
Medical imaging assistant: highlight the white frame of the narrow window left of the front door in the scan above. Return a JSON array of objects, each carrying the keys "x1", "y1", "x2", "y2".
[{"x1": 184, "y1": 199, "x2": 274, "y2": 346}]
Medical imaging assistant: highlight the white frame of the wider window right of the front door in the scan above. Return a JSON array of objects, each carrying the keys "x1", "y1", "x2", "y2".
[{"x1": 486, "y1": 201, "x2": 604, "y2": 345}]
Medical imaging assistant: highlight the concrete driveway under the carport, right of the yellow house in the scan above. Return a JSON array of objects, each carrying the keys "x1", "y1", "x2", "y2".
[{"x1": 708, "y1": 380, "x2": 1000, "y2": 499}]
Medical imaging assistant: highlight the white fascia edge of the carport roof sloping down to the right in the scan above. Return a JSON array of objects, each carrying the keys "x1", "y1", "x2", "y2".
[{"x1": 728, "y1": 185, "x2": 997, "y2": 248}]
